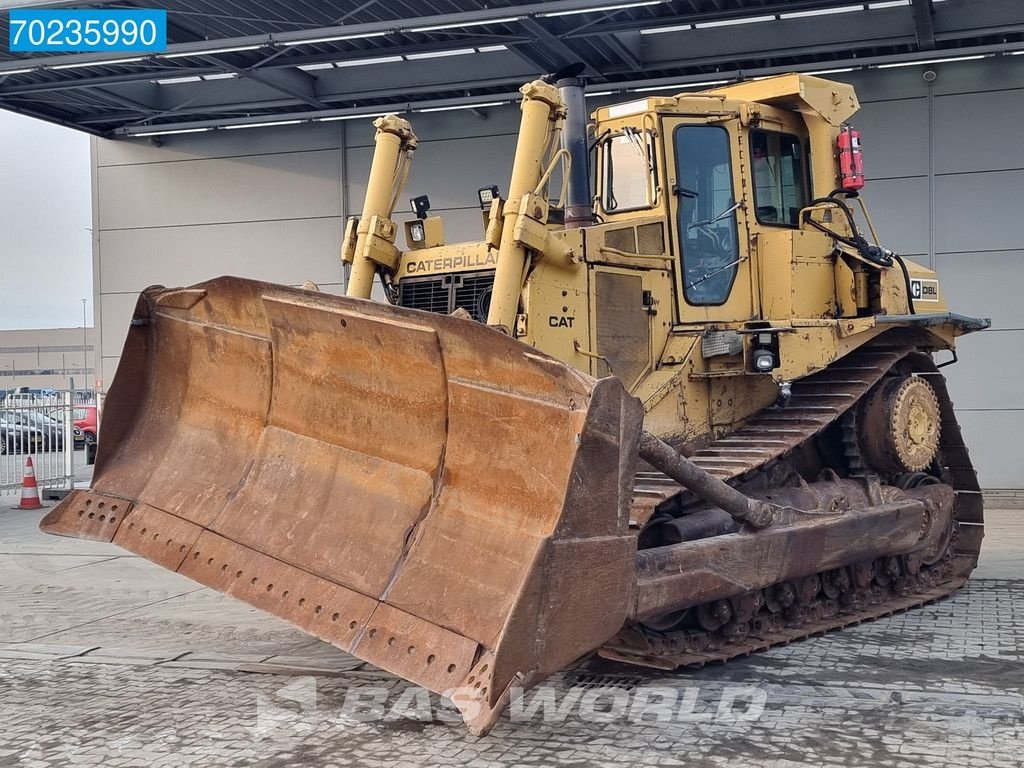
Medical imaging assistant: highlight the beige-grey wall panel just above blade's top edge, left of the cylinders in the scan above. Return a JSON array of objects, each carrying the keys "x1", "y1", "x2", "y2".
[{"x1": 100, "y1": 216, "x2": 343, "y2": 293}]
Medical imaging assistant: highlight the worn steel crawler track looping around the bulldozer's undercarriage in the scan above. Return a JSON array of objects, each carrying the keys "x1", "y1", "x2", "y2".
[{"x1": 598, "y1": 344, "x2": 984, "y2": 669}]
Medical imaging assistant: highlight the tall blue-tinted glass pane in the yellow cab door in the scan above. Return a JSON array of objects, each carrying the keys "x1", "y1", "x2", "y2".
[{"x1": 673, "y1": 125, "x2": 739, "y2": 306}]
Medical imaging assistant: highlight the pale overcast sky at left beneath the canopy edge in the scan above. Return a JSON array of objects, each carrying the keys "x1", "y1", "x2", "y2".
[{"x1": 0, "y1": 110, "x2": 92, "y2": 329}]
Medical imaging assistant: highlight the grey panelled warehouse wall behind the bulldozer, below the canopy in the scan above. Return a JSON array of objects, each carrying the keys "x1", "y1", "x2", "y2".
[{"x1": 93, "y1": 56, "x2": 1024, "y2": 487}]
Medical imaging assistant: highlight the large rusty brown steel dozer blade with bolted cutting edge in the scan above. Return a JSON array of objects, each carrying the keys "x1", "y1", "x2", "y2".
[{"x1": 41, "y1": 278, "x2": 643, "y2": 732}]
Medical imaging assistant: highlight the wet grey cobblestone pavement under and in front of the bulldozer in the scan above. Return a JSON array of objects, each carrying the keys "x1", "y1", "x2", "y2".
[{"x1": 0, "y1": 512, "x2": 1024, "y2": 768}]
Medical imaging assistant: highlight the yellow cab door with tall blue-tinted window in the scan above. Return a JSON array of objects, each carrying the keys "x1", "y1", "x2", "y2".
[{"x1": 666, "y1": 119, "x2": 759, "y2": 323}]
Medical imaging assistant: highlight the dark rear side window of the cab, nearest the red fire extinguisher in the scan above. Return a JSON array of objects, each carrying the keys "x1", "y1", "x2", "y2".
[{"x1": 751, "y1": 130, "x2": 808, "y2": 226}]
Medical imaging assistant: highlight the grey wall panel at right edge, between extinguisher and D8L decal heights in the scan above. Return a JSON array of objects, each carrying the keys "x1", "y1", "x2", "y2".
[{"x1": 935, "y1": 170, "x2": 1024, "y2": 253}]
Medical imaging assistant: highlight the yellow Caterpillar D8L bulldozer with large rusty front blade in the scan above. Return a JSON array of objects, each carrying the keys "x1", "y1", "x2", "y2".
[{"x1": 42, "y1": 75, "x2": 988, "y2": 732}]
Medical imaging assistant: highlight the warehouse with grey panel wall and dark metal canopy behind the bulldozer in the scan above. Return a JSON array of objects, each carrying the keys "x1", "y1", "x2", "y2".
[{"x1": 0, "y1": 0, "x2": 1024, "y2": 487}]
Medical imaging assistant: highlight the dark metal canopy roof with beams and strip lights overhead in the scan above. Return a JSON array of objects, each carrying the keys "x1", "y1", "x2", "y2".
[{"x1": 0, "y1": 0, "x2": 1024, "y2": 136}]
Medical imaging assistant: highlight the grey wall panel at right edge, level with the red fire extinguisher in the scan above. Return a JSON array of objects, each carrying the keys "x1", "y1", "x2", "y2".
[{"x1": 934, "y1": 90, "x2": 1024, "y2": 174}]
